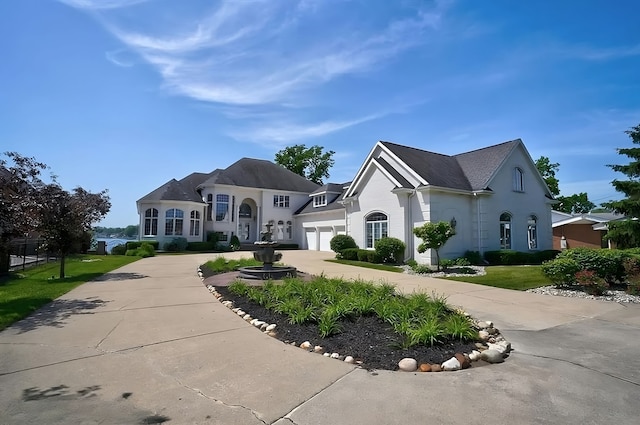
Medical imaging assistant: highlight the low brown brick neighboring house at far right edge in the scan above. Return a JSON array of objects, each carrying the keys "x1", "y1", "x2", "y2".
[{"x1": 552, "y1": 210, "x2": 624, "y2": 249}]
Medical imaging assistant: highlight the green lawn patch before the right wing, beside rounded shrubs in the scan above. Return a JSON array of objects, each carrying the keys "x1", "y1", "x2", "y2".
[{"x1": 444, "y1": 266, "x2": 552, "y2": 291}]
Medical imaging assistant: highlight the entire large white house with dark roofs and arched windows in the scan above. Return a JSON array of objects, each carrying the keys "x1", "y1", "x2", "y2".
[{"x1": 138, "y1": 139, "x2": 554, "y2": 264}]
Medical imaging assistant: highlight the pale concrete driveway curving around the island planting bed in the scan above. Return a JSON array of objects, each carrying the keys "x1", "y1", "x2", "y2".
[{"x1": 0, "y1": 251, "x2": 640, "y2": 425}]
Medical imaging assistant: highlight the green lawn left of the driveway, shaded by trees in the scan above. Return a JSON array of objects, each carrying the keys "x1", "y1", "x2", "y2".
[{"x1": 0, "y1": 255, "x2": 140, "y2": 330}]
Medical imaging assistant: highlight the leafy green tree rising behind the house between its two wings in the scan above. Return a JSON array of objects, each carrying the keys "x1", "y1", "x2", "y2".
[{"x1": 275, "y1": 145, "x2": 335, "y2": 184}]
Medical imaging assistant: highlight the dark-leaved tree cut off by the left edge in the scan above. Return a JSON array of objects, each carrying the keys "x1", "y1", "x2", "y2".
[{"x1": 0, "y1": 152, "x2": 54, "y2": 274}]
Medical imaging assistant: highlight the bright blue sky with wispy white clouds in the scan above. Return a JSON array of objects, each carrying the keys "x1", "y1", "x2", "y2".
[{"x1": 0, "y1": 0, "x2": 640, "y2": 226}]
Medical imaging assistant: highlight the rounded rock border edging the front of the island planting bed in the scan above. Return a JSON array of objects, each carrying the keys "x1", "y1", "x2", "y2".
[{"x1": 198, "y1": 268, "x2": 512, "y2": 372}]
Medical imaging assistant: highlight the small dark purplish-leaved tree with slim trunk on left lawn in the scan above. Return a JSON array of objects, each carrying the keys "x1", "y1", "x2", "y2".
[{"x1": 37, "y1": 184, "x2": 111, "y2": 279}]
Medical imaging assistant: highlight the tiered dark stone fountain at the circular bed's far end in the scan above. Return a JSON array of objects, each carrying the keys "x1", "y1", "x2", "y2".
[{"x1": 239, "y1": 223, "x2": 296, "y2": 280}]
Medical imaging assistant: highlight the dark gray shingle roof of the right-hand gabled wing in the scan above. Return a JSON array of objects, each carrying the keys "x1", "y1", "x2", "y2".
[{"x1": 377, "y1": 139, "x2": 522, "y2": 190}]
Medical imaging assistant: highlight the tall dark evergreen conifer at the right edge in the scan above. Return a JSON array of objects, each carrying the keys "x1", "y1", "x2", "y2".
[{"x1": 602, "y1": 124, "x2": 640, "y2": 248}]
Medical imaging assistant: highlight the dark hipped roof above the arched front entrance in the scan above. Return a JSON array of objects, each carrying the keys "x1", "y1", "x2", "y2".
[{"x1": 199, "y1": 158, "x2": 319, "y2": 193}]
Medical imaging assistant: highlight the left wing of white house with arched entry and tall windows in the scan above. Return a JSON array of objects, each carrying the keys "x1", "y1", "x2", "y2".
[{"x1": 137, "y1": 158, "x2": 318, "y2": 247}]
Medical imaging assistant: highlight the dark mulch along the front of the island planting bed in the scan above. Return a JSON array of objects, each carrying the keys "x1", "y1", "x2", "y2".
[{"x1": 204, "y1": 273, "x2": 475, "y2": 370}]
